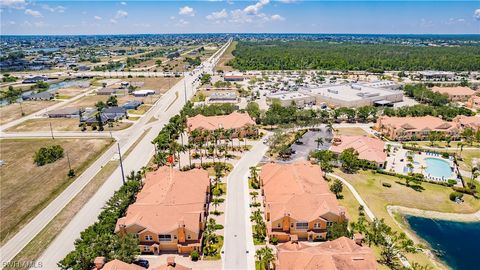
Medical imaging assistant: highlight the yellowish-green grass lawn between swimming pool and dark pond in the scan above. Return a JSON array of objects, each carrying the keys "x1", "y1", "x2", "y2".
[{"x1": 335, "y1": 170, "x2": 480, "y2": 264}]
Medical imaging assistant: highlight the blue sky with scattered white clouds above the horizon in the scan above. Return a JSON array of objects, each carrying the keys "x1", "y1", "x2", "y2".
[{"x1": 0, "y1": 0, "x2": 480, "y2": 35}]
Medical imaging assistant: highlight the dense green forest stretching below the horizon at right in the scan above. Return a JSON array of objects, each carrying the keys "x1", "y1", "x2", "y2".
[{"x1": 228, "y1": 41, "x2": 480, "y2": 71}]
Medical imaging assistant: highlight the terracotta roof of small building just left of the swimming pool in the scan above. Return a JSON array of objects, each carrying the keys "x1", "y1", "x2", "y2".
[{"x1": 330, "y1": 136, "x2": 387, "y2": 162}]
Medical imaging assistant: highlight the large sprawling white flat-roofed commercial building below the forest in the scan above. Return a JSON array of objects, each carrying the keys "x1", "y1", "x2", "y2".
[{"x1": 299, "y1": 84, "x2": 403, "y2": 108}]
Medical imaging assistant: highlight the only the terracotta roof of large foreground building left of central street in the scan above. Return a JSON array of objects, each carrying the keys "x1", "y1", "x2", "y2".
[{"x1": 115, "y1": 166, "x2": 210, "y2": 234}]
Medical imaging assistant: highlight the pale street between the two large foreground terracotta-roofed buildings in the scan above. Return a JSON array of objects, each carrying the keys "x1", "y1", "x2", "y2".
[{"x1": 222, "y1": 139, "x2": 268, "y2": 270}]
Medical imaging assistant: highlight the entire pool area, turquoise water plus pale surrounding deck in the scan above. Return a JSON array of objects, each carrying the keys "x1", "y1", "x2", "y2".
[{"x1": 386, "y1": 147, "x2": 461, "y2": 185}]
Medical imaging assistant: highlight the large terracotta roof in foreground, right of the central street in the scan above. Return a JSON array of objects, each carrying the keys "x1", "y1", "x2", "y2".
[{"x1": 260, "y1": 161, "x2": 345, "y2": 221}]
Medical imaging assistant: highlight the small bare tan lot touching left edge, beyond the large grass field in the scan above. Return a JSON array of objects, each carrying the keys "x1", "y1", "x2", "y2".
[{"x1": 0, "y1": 101, "x2": 57, "y2": 124}]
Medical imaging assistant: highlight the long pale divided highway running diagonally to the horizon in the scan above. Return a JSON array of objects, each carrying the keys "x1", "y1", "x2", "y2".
[{"x1": 0, "y1": 38, "x2": 228, "y2": 269}]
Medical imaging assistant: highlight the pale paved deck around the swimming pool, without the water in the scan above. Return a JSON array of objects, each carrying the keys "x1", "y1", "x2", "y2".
[{"x1": 386, "y1": 147, "x2": 461, "y2": 185}]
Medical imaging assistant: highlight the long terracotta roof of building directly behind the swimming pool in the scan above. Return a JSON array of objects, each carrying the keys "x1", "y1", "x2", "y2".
[{"x1": 378, "y1": 116, "x2": 455, "y2": 131}]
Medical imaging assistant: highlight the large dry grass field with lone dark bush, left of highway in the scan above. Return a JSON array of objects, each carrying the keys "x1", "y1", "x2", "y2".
[{"x1": 0, "y1": 139, "x2": 112, "y2": 242}]
